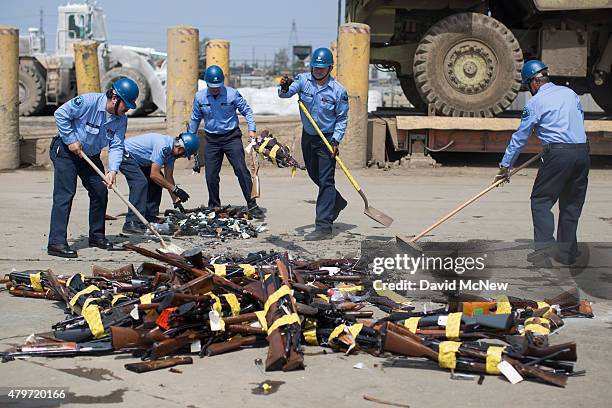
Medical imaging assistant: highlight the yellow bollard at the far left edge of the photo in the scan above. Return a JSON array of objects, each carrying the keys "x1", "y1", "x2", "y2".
[{"x1": 0, "y1": 26, "x2": 19, "y2": 170}]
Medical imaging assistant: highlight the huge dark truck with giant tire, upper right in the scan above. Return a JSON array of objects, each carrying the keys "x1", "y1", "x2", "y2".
[{"x1": 346, "y1": 0, "x2": 612, "y2": 117}]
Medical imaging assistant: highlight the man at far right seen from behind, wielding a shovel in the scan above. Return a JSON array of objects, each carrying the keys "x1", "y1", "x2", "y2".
[{"x1": 495, "y1": 60, "x2": 590, "y2": 266}]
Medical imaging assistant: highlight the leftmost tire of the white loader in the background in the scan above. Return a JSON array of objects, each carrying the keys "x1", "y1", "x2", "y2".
[{"x1": 19, "y1": 62, "x2": 47, "y2": 116}]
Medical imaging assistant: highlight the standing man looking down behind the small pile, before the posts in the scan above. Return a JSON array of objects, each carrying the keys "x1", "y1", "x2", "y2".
[{"x1": 189, "y1": 65, "x2": 264, "y2": 219}]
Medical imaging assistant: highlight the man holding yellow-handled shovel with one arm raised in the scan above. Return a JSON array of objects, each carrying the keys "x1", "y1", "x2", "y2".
[{"x1": 278, "y1": 48, "x2": 348, "y2": 241}]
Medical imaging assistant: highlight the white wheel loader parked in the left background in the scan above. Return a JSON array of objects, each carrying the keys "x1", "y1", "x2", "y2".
[{"x1": 19, "y1": 2, "x2": 166, "y2": 116}]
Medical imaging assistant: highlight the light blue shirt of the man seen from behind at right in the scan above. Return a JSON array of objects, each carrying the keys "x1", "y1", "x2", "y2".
[{"x1": 500, "y1": 82, "x2": 587, "y2": 167}]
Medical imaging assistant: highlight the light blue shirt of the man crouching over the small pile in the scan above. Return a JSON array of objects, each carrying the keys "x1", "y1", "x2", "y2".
[{"x1": 125, "y1": 133, "x2": 176, "y2": 169}]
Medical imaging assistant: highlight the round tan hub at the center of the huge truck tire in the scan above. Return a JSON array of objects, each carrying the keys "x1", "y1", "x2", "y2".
[{"x1": 444, "y1": 40, "x2": 497, "y2": 94}]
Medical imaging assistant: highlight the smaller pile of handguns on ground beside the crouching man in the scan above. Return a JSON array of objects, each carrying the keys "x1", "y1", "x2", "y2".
[{"x1": 158, "y1": 206, "x2": 266, "y2": 241}]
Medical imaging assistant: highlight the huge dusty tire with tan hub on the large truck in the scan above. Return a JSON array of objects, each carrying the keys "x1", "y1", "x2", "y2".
[{"x1": 413, "y1": 13, "x2": 523, "y2": 117}]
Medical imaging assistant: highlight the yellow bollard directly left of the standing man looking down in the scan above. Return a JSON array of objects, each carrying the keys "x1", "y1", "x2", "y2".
[{"x1": 166, "y1": 26, "x2": 199, "y2": 136}]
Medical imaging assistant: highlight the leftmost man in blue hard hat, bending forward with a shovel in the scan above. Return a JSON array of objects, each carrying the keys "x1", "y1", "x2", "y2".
[{"x1": 47, "y1": 78, "x2": 138, "y2": 258}]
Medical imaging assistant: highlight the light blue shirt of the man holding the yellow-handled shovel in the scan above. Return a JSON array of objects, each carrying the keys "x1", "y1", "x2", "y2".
[{"x1": 278, "y1": 73, "x2": 348, "y2": 143}]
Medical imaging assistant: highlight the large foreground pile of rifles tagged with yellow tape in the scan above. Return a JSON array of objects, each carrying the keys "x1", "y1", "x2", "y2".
[{"x1": 2, "y1": 245, "x2": 593, "y2": 387}]
